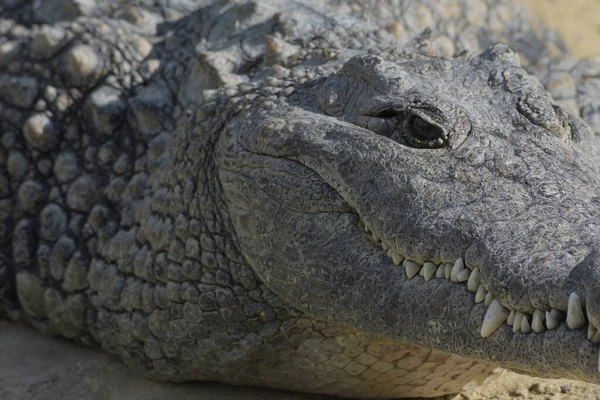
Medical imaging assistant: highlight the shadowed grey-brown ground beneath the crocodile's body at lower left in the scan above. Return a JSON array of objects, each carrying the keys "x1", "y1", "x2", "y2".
[{"x1": 0, "y1": 320, "x2": 327, "y2": 400}]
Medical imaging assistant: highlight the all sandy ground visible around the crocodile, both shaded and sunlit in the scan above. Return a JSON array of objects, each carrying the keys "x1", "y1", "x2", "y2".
[{"x1": 0, "y1": 0, "x2": 600, "y2": 400}]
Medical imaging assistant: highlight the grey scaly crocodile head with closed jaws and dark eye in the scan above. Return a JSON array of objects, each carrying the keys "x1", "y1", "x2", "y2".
[{"x1": 217, "y1": 45, "x2": 600, "y2": 390}]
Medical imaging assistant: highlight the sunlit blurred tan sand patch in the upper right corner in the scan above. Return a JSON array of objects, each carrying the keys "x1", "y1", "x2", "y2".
[{"x1": 525, "y1": 0, "x2": 600, "y2": 57}]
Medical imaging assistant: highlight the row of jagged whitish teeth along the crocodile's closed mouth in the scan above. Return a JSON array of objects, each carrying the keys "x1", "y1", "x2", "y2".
[{"x1": 358, "y1": 220, "x2": 600, "y2": 371}]
